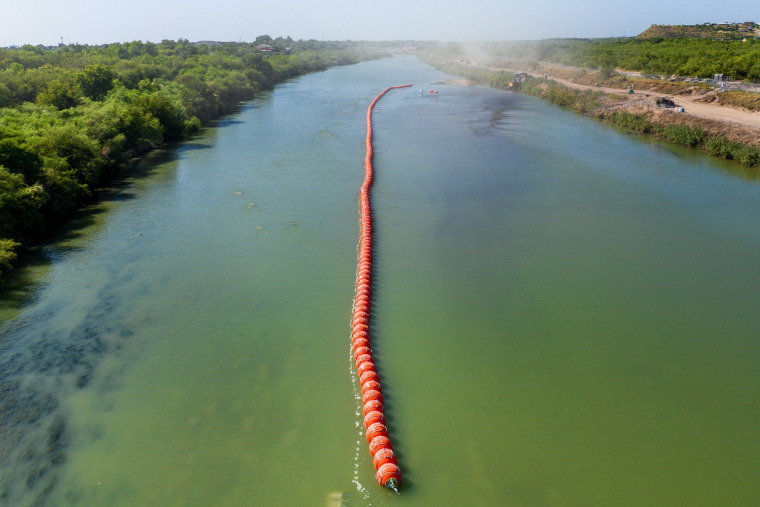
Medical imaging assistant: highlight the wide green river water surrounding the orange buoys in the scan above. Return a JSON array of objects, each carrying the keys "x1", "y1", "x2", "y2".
[{"x1": 0, "y1": 56, "x2": 760, "y2": 506}]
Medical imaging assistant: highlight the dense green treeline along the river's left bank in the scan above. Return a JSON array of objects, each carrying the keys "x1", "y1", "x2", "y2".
[{"x1": 0, "y1": 36, "x2": 382, "y2": 280}]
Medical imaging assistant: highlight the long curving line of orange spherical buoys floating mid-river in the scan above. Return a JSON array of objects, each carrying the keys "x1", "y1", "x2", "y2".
[{"x1": 351, "y1": 84, "x2": 412, "y2": 490}]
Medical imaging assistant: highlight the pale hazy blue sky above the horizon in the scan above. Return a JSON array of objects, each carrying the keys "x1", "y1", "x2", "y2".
[{"x1": 0, "y1": 0, "x2": 760, "y2": 46}]
